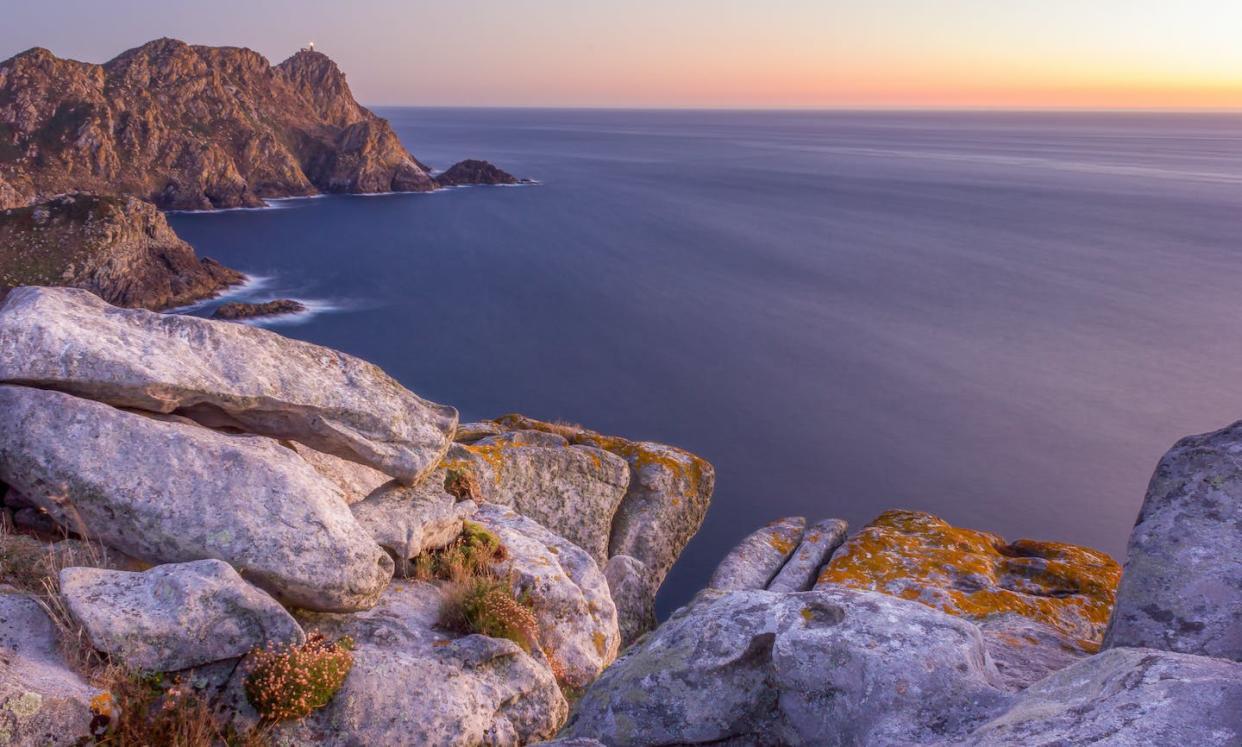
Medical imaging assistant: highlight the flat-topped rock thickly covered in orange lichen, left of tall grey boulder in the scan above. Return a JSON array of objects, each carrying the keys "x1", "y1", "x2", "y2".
[{"x1": 818, "y1": 511, "x2": 1122, "y2": 653}]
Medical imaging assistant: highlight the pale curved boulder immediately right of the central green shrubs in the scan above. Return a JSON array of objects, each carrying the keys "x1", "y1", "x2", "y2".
[{"x1": 473, "y1": 505, "x2": 621, "y2": 687}]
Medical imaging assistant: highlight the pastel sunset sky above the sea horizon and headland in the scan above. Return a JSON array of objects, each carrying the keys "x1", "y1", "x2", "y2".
[{"x1": 0, "y1": 0, "x2": 1242, "y2": 109}]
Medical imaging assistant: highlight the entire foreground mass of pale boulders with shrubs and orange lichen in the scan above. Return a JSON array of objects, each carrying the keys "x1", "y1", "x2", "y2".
[{"x1": 0, "y1": 287, "x2": 1242, "y2": 747}]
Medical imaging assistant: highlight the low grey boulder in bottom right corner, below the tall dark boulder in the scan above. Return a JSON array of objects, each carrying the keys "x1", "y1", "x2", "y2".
[{"x1": 959, "y1": 649, "x2": 1242, "y2": 747}]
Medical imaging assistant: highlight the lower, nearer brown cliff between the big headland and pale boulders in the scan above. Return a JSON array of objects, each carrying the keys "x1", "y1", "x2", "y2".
[{"x1": 0, "y1": 194, "x2": 243, "y2": 308}]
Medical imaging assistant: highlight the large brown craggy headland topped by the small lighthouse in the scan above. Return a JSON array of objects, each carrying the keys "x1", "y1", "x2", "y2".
[{"x1": 0, "y1": 39, "x2": 436, "y2": 209}]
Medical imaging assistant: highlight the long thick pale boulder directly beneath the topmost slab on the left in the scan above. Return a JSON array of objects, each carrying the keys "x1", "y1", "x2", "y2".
[{"x1": 0, "y1": 385, "x2": 392, "y2": 610}]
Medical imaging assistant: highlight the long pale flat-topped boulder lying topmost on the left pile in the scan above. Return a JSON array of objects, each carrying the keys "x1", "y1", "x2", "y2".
[{"x1": 0, "y1": 287, "x2": 457, "y2": 482}]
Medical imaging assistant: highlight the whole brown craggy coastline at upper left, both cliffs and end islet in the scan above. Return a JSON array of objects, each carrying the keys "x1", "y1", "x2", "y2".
[{"x1": 0, "y1": 39, "x2": 529, "y2": 309}]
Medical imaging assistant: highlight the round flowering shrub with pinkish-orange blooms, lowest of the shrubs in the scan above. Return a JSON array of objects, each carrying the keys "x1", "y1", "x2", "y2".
[{"x1": 246, "y1": 631, "x2": 354, "y2": 721}]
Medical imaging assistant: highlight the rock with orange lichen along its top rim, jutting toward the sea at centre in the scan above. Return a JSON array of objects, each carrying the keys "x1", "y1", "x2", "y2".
[{"x1": 493, "y1": 414, "x2": 715, "y2": 643}]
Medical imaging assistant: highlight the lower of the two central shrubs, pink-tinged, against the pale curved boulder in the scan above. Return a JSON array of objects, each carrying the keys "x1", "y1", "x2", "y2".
[{"x1": 440, "y1": 575, "x2": 539, "y2": 653}]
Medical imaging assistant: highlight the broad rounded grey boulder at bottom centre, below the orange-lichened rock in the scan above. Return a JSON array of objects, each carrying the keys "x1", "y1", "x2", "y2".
[{"x1": 561, "y1": 587, "x2": 1007, "y2": 747}]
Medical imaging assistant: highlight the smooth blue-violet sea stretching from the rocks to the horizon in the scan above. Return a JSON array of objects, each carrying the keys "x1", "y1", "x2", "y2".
[{"x1": 171, "y1": 109, "x2": 1242, "y2": 613}]
